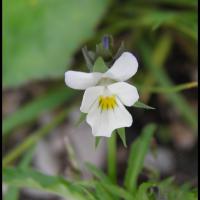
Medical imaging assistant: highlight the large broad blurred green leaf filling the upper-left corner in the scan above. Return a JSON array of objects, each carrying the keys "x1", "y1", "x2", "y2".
[{"x1": 3, "y1": 0, "x2": 109, "y2": 87}]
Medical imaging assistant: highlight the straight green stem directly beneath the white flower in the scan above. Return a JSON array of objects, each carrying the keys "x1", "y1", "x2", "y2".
[{"x1": 108, "y1": 133, "x2": 117, "y2": 183}]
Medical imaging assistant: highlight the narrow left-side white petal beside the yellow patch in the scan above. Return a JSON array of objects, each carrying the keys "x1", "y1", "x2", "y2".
[{"x1": 80, "y1": 86, "x2": 104, "y2": 113}]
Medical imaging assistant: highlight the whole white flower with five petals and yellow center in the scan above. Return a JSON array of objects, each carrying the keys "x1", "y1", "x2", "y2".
[{"x1": 65, "y1": 52, "x2": 139, "y2": 137}]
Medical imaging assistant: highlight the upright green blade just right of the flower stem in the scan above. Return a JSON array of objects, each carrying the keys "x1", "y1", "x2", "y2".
[{"x1": 124, "y1": 124, "x2": 156, "y2": 193}]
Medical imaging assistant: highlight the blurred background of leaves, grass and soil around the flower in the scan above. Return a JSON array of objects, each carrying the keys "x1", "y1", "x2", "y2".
[{"x1": 2, "y1": 0, "x2": 198, "y2": 200}]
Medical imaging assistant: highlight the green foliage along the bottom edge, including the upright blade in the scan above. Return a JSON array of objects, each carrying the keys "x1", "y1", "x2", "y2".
[{"x1": 3, "y1": 124, "x2": 197, "y2": 200}]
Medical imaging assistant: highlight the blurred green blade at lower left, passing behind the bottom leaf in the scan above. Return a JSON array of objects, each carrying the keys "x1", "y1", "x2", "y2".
[{"x1": 3, "y1": 147, "x2": 35, "y2": 200}]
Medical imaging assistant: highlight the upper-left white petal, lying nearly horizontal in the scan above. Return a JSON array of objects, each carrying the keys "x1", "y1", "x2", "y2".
[{"x1": 65, "y1": 71, "x2": 102, "y2": 90}]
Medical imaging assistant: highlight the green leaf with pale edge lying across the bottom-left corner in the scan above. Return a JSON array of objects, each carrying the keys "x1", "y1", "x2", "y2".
[{"x1": 3, "y1": 168, "x2": 85, "y2": 200}]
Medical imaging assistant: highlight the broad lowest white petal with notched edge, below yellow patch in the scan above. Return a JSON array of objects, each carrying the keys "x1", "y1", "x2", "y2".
[{"x1": 86, "y1": 100, "x2": 133, "y2": 137}]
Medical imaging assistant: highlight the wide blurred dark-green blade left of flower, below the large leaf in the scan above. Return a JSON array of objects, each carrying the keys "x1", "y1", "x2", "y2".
[{"x1": 3, "y1": 87, "x2": 76, "y2": 135}]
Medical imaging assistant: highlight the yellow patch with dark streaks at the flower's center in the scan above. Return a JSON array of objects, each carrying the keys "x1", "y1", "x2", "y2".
[{"x1": 99, "y1": 95, "x2": 117, "y2": 111}]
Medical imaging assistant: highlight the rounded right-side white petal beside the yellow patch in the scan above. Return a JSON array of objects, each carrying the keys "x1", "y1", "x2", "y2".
[{"x1": 108, "y1": 82, "x2": 139, "y2": 106}]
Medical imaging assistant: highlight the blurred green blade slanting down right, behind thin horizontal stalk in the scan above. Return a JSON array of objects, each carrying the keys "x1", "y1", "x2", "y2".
[{"x1": 140, "y1": 38, "x2": 197, "y2": 131}]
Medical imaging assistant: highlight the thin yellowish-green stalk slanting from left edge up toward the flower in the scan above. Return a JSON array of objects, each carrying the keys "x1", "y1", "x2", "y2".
[{"x1": 3, "y1": 106, "x2": 74, "y2": 166}]
